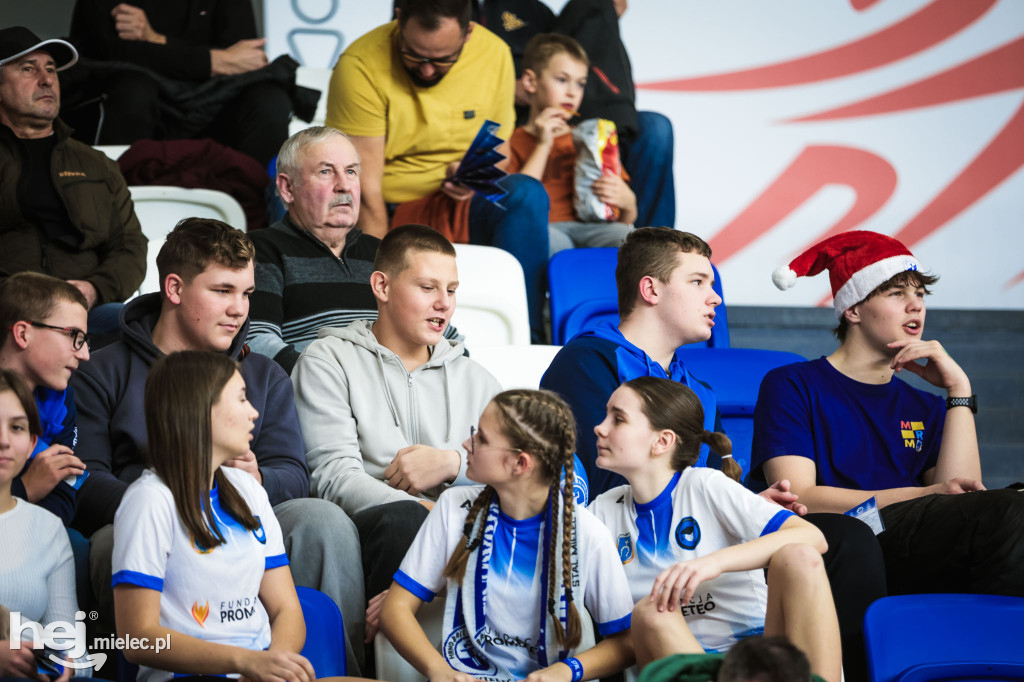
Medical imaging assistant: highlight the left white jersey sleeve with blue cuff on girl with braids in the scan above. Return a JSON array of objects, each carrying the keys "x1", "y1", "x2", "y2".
[{"x1": 394, "y1": 488, "x2": 466, "y2": 601}]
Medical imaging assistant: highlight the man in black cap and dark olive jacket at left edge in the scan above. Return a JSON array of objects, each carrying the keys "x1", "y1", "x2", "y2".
[{"x1": 0, "y1": 27, "x2": 146, "y2": 331}]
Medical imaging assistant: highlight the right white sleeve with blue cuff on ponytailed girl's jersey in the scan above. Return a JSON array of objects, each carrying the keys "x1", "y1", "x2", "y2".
[{"x1": 692, "y1": 469, "x2": 796, "y2": 543}]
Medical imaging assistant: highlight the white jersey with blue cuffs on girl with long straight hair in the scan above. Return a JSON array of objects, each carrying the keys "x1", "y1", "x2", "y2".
[{"x1": 113, "y1": 467, "x2": 288, "y2": 682}]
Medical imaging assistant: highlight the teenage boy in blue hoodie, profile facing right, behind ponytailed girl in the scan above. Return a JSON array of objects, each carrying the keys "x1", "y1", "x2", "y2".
[{"x1": 541, "y1": 227, "x2": 885, "y2": 680}]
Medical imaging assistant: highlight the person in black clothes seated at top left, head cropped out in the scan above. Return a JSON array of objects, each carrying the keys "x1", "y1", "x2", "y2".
[{"x1": 71, "y1": 0, "x2": 291, "y2": 166}]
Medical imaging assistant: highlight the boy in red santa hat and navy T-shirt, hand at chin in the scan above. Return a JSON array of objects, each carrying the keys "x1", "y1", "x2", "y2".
[{"x1": 751, "y1": 231, "x2": 1024, "y2": 596}]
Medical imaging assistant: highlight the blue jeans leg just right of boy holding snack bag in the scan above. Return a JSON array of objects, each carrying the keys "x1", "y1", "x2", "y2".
[{"x1": 621, "y1": 112, "x2": 676, "y2": 227}]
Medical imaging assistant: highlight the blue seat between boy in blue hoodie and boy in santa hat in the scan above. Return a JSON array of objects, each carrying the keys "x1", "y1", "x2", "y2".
[{"x1": 681, "y1": 344, "x2": 806, "y2": 476}]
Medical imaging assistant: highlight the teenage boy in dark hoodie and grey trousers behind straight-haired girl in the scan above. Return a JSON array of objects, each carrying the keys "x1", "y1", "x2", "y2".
[{"x1": 75, "y1": 218, "x2": 362, "y2": 672}]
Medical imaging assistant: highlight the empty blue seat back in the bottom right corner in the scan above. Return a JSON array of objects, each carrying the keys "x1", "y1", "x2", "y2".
[{"x1": 864, "y1": 594, "x2": 1024, "y2": 682}]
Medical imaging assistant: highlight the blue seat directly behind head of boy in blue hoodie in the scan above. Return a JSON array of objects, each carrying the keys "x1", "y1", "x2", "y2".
[{"x1": 548, "y1": 248, "x2": 729, "y2": 348}]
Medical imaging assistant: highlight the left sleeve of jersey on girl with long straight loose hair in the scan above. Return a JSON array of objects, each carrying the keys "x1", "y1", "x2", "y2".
[{"x1": 111, "y1": 479, "x2": 178, "y2": 592}]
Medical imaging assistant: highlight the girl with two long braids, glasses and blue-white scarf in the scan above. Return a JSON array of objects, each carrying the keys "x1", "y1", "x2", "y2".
[{"x1": 381, "y1": 390, "x2": 633, "y2": 682}]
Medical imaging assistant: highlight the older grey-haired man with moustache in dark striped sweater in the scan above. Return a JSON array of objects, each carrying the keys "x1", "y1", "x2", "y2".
[{"x1": 247, "y1": 126, "x2": 456, "y2": 372}]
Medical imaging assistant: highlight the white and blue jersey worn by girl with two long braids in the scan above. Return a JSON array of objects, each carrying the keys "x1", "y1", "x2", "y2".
[{"x1": 394, "y1": 485, "x2": 633, "y2": 679}]
